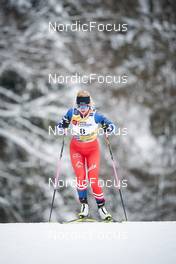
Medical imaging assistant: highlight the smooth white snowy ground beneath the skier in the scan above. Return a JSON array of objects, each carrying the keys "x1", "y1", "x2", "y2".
[{"x1": 0, "y1": 222, "x2": 176, "y2": 264}]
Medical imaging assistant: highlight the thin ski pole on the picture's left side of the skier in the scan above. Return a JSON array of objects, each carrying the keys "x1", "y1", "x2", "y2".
[{"x1": 49, "y1": 131, "x2": 65, "y2": 222}]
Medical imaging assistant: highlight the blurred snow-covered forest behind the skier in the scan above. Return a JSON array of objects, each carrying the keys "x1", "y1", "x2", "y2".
[{"x1": 0, "y1": 0, "x2": 176, "y2": 222}]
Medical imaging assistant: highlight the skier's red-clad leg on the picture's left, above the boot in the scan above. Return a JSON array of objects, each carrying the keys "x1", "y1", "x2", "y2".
[{"x1": 70, "y1": 141, "x2": 87, "y2": 203}]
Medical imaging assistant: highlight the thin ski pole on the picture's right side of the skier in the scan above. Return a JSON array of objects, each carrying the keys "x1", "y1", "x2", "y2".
[{"x1": 105, "y1": 133, "x2": 128, "y2": 221}]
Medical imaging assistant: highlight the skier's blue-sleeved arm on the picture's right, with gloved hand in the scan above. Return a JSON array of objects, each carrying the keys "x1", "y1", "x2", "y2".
[{"x1": 95, "y1": 112, "x2": 115, "y2": 133}]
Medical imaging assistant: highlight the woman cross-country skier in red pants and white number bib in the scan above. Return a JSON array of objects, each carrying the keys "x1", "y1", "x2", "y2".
[{"x1": 58, "y1": 91, "x2": 115, "y2": 220}]
